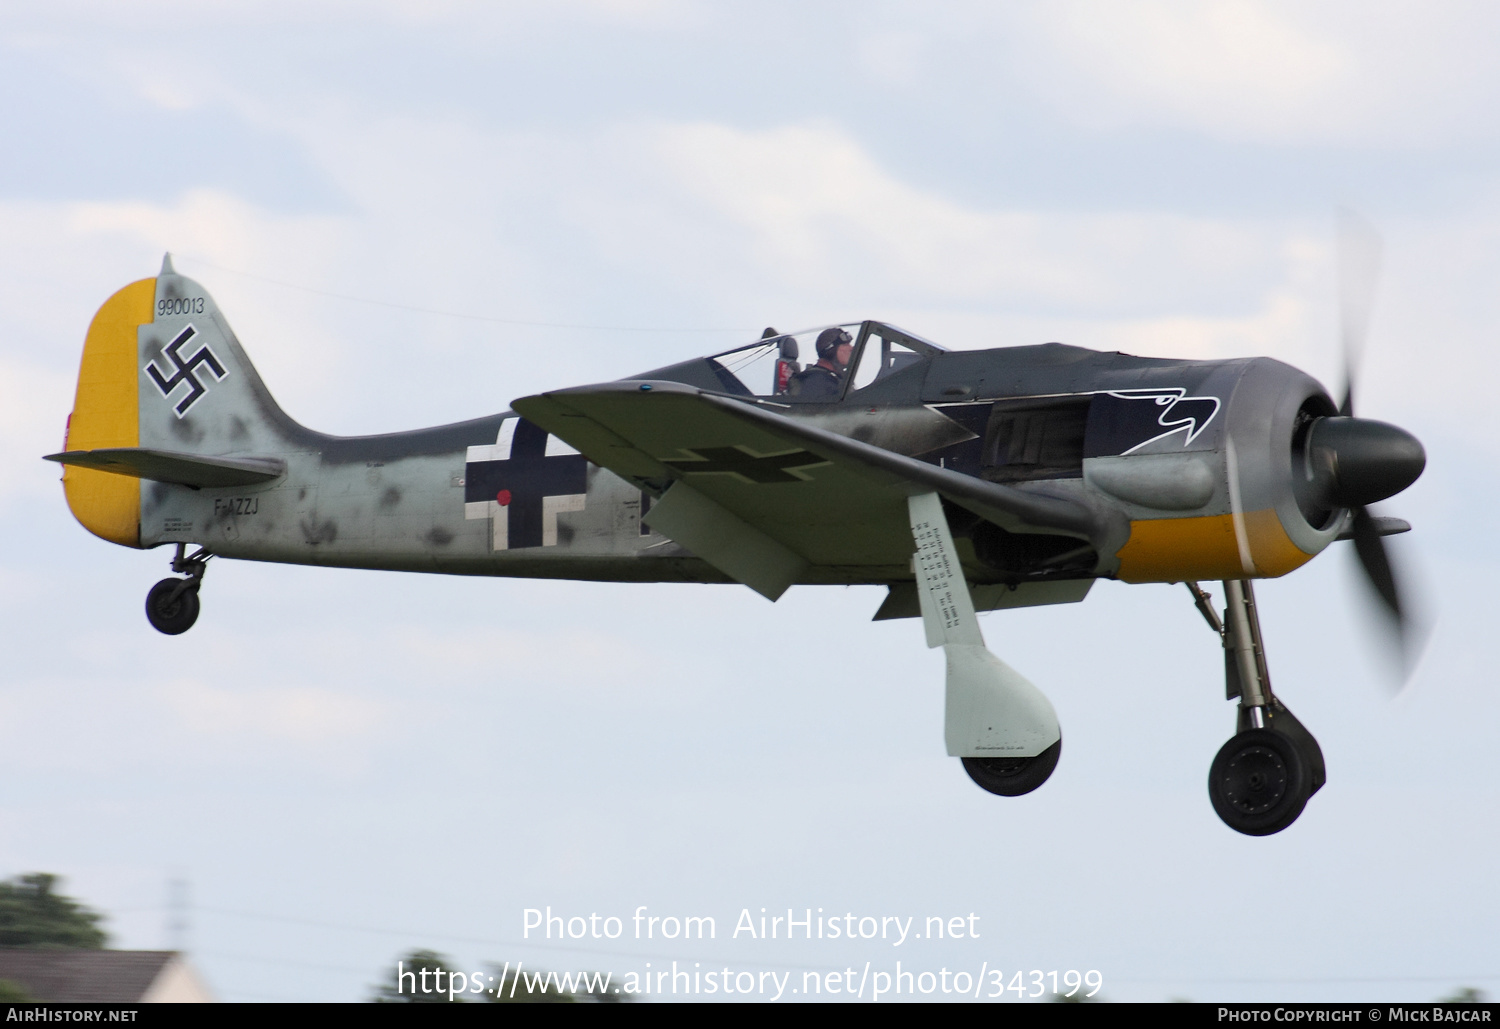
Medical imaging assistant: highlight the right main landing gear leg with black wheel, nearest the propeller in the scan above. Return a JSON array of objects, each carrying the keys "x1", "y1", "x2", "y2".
[{"x1": 1187, "y1": 579, "x2": 1328, "y2": 836}]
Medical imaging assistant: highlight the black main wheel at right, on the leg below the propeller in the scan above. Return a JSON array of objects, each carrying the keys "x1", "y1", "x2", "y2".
[{"x1": 1209, "y1": 729, "x2": 1311, "y2": 836}]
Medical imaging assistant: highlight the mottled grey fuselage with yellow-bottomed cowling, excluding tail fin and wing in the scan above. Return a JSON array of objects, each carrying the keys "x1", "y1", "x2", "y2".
[{"x1": 141, "y1": 336, "x2": 1338, "y2": 594}]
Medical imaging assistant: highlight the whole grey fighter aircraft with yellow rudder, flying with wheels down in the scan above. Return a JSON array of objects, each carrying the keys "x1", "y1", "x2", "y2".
[{"x1": 48, "y1": 232, "x2": 1425, "y2": 836}]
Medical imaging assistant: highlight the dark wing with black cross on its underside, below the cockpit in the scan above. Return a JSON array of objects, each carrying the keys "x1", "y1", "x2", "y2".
[{"x1": 513, "y1": 380, "x2": 1103, "y2": 600}]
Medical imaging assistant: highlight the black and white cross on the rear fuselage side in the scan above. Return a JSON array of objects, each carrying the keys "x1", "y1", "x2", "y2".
[{"x1": 464, "y1": 419, "x2": 588, "y2": 551}]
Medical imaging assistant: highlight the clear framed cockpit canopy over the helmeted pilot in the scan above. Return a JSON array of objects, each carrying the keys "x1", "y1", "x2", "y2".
[{"x1": 636, "y1": 321, "x2": 945, "y2": 404}]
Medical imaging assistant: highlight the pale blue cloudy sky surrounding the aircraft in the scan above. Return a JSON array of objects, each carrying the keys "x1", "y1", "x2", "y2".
[{"x1": 0, "y1": 0, "x2": 1500, "y2": 1004}]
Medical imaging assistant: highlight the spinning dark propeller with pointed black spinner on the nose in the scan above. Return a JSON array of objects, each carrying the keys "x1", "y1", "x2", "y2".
[{"x1": 1299, "y1": 210, "x2": 1427, "y2": 674}]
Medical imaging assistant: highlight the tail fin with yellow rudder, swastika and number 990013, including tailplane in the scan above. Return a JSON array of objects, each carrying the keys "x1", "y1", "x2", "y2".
[{"x1": 50, "y1": 255, "x2": 306, "y2": 548}]
